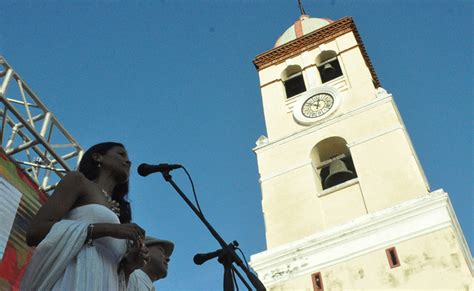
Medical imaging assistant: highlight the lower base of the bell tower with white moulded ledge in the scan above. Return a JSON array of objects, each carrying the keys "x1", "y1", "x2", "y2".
[{"x1": 251, "y1": 190, "x2": 474, "y2": 290}]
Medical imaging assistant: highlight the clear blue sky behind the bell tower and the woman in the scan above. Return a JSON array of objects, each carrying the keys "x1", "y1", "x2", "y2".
[{"x1": 0, "y1": 0, "x2": 474, "y2": 290}]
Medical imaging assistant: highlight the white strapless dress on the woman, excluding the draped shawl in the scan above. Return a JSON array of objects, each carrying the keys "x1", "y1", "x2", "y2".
[{"x1": 52, "y1": 204, "x2": 127, "y2": 290}]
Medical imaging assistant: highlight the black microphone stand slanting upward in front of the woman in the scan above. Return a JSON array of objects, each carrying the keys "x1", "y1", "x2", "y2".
[{"x1": 161, "y1": 170, "x2": 266, "y2": 291}]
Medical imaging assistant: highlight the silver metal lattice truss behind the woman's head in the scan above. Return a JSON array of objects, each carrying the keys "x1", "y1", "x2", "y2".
[{"x1": 0, "y1": 56, "x2": 84, "y2": 192}]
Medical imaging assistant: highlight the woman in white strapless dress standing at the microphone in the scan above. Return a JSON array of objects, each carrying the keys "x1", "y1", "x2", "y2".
[{"x1": 21, "y1": 142, "x2": 149, "y2": 290}]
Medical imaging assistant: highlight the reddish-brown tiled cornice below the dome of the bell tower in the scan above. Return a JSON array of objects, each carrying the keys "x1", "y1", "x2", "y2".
[{"x1": 253, "y1": 17, "x2": 380, "y2": 88}]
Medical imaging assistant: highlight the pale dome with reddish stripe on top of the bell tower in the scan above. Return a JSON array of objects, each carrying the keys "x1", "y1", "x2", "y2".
[{"x1": 274, "y1": 15, "x2": 333, "y2": 47}]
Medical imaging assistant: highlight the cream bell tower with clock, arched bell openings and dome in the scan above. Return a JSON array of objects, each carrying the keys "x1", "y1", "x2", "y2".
[{"x1": 251, "y1": 15, "x2": 472, "y2": 290}]
